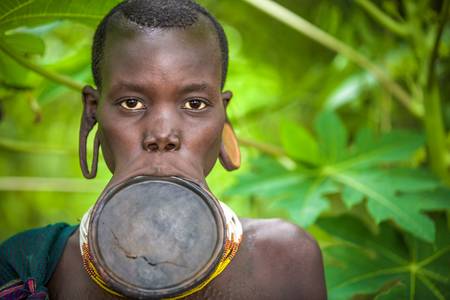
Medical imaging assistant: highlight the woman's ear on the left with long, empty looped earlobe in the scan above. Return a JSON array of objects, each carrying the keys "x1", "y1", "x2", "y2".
[{"x1": 78, "y1": 86, "x2": 100, "y2": 179}]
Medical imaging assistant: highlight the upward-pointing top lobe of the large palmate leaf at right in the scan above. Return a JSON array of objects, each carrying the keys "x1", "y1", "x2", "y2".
[{"x1": 315, "y1": 111, "x2": 348, "y2": 163}]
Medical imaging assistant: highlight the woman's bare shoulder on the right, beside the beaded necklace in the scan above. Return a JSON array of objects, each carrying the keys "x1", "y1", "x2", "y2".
[{"x1": 242, "y1": 219, "x2": 326, "y2": 299}]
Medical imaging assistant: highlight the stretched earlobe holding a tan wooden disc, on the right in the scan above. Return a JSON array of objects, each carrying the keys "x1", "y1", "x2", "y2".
[{"x1": 219, "y1": 122, "x2": 241, "y2": 171}]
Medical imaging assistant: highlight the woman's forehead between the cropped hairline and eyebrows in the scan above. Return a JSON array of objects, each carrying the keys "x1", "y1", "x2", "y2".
[{"x1": 101, "y1": 18, "x2": 222, "y2": 89}]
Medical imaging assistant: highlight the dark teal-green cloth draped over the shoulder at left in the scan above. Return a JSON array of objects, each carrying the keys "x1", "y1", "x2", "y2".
[{"x1": 0, "y1": 223, "x2": 78, "y2": 292}]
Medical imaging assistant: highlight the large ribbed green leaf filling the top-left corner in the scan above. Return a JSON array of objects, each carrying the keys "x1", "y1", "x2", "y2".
[{"x1": 0, "y1": 0, "x2": 120, "y2": 32}]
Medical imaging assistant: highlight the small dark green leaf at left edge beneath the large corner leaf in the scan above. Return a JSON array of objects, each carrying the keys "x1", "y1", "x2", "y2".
[{"x1": 3, "y1": 33, "x2": 45, "y2": 55}]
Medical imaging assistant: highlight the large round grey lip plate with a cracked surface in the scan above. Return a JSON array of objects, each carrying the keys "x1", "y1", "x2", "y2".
[{"x1": 88, "y1": 176, "x2": 226, "y2": 299}]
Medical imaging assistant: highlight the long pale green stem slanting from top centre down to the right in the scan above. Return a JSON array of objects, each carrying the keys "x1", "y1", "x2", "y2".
[{"x1": 243, "y1": 0, "x2": 423, "y2": 118}]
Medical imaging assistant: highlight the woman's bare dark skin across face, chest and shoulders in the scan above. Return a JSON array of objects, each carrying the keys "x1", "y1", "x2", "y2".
[{"x1": 48, "y1": 18, "x2": 326, "y2": 299}]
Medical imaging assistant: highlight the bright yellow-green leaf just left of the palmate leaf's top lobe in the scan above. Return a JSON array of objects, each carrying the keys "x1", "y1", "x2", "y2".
[{"x1": 281, "y1": 121, "x2": 319, "y2": 164}]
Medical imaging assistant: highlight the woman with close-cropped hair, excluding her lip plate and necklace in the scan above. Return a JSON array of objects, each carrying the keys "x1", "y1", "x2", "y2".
[{"x1": 0, "y1": 0, "x2": 326, "y2": 299}]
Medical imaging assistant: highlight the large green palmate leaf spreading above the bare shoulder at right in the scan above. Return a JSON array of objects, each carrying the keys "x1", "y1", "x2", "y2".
[{"x1": 231, "y1": 112, "x2": 450, "y2": 241}]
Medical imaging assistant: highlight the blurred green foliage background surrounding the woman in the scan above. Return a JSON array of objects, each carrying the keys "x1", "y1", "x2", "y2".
[{"x1": 0, "y1": 0, "x2": 450, "y2": 299}]
